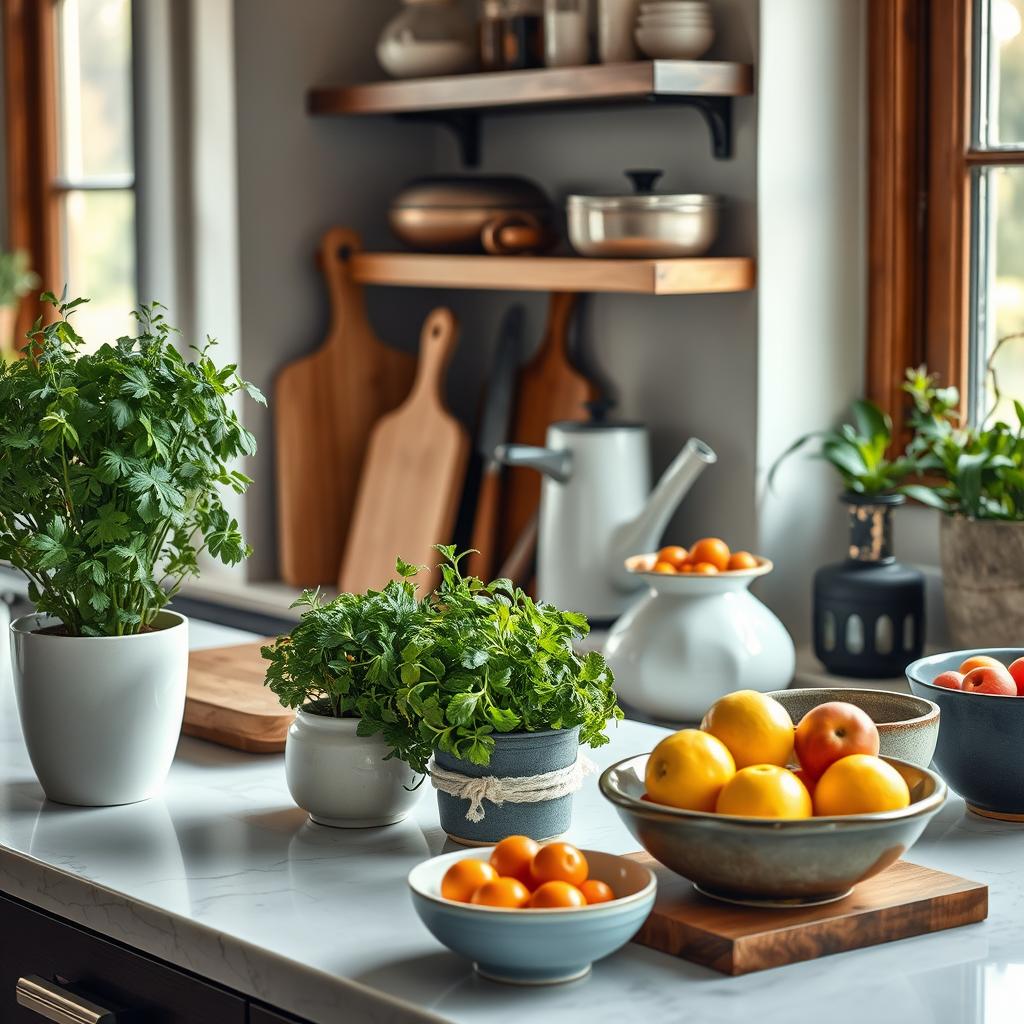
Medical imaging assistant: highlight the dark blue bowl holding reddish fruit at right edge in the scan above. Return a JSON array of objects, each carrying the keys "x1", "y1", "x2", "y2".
[{"x1": 906, "y1": 647, "x2": 1024, "y2": 821}]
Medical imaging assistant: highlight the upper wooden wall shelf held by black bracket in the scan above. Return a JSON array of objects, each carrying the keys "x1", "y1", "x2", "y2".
[{"x1": 308, "y1": 60, "x2": 754, "y2": 114}]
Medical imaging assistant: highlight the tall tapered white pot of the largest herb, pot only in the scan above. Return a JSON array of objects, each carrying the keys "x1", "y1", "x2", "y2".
[{"x1": 10, "y1": 611, "x2": 188, "y2": 807}]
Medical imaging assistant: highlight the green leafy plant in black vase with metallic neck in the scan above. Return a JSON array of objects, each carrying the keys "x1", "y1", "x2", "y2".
[{"x1": 769, "y1": 400, "x2": 925, "y2": 678}]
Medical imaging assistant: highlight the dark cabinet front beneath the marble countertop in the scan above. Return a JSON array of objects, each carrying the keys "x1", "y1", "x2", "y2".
[{"x1": 0, "y1": 897, "x2": 246, "y2": 1024}]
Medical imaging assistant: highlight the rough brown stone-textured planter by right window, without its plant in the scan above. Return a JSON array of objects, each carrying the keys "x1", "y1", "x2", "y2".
[{"x1": 939, "y1": 516, "x2": 1024, "y2": 649}]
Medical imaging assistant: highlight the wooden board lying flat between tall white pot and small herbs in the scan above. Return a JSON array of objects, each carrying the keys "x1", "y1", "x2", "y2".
[{"x1": 181, "y1": 640, "x2": 295, "y2": 754}]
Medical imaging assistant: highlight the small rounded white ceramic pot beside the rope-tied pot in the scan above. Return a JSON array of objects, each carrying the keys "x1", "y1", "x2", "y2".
[{"x1": 285, "y1": 708, "x2": 425, "y2": 828}]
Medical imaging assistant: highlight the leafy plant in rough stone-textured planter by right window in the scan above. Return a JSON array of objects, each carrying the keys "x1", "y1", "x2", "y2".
[{"x1": 904, "y1": 362, "x2": 1024, "y2": 647}]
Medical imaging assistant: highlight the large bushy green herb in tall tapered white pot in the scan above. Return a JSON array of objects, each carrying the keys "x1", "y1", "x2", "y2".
[{"x1": 0, "y1": 295, "x2": 263, "y2": 806}]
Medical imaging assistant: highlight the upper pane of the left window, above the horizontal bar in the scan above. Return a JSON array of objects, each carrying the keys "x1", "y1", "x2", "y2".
[{"x1": 57, "y1": 0, "x2": 133, "y2": 181}]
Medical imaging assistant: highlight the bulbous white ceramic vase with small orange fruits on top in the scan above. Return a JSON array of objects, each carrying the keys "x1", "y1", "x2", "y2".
[{"x1": 604, "y1": 555, "x2": 796, "y2": 723}]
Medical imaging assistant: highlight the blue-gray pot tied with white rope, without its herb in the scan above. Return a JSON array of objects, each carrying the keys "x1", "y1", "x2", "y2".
[{"x1": 434, "y1": 726, "x2": 580, "y2": 846}]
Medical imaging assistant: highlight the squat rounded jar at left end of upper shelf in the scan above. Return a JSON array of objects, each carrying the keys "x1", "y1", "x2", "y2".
[{"x1": 377, "y1": 0, "x2": 477, "y2": 78}]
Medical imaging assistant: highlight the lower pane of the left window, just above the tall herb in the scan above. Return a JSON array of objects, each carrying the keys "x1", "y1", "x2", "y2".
[{"x1": 63, "y1": 191, "x2": 136, "y2": 349}]
